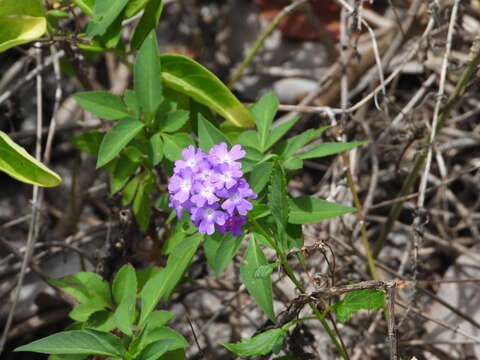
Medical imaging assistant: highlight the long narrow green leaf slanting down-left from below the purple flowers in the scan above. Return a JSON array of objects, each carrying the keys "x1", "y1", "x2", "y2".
[{"x1": 139, "y1": 233, "x2": 202, "y2": 325}]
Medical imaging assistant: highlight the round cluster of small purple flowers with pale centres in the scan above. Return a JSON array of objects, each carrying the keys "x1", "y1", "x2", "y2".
[{"x1": 168, "y1": 142, "x2": 257, "y2": 236}]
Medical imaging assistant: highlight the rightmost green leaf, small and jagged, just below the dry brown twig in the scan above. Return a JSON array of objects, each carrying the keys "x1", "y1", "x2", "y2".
[{"x1": 335, "y1": 289, "x2": 385, "y2": 322}]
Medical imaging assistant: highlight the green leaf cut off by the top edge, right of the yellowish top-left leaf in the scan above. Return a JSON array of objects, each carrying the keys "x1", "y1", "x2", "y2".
[{"x1": 87, "y1": 0, "x2": 129, "y2": 36}]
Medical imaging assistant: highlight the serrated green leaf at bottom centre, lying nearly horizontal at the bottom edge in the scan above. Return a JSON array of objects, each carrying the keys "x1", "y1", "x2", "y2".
[{"x1": 222, "y1": 329, "x2": 285, "y2": 356}]
